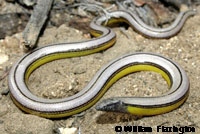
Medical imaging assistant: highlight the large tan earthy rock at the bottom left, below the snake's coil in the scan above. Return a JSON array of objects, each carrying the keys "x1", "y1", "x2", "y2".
[{"x1": 4, "y1": 113, "x2": 54, "y2": 134}]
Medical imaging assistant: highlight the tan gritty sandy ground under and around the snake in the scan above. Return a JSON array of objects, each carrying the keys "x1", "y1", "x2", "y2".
[{"x1": 0, "y1": 4, "x2": 200, "y2": 134}]
